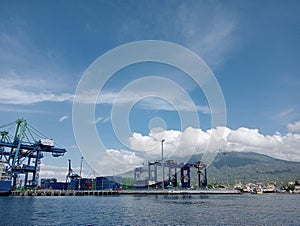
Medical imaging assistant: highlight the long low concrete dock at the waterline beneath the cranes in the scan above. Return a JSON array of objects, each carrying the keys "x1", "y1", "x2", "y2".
[{"x1": 10, "y1": 189, "x2": 241, "y2": 196}]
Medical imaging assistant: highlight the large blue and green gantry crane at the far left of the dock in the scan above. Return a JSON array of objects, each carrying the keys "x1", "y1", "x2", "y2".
[{"x1": 0, "y1": 119, "x2": 66, "y2": 187}]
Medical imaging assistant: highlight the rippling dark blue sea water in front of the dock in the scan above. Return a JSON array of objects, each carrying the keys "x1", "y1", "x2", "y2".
[{"x1": 0, "y1": 194, "x2": 300, "y2": 225}]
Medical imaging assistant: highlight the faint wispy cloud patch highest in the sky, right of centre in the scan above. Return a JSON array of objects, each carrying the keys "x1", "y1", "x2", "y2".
[{"x1": 177, "y1": 2, "x2": 238, "y2": 65}]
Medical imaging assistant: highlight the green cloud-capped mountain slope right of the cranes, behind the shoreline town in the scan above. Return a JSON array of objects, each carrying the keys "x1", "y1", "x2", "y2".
[{"x1": 190, "y1": 152, "x2": 300, "y2": 184}]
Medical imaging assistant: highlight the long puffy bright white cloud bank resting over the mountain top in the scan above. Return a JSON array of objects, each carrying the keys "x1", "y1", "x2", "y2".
[{"x1": 125, "y1": 123, "x2": 300, "y2": 164}]
